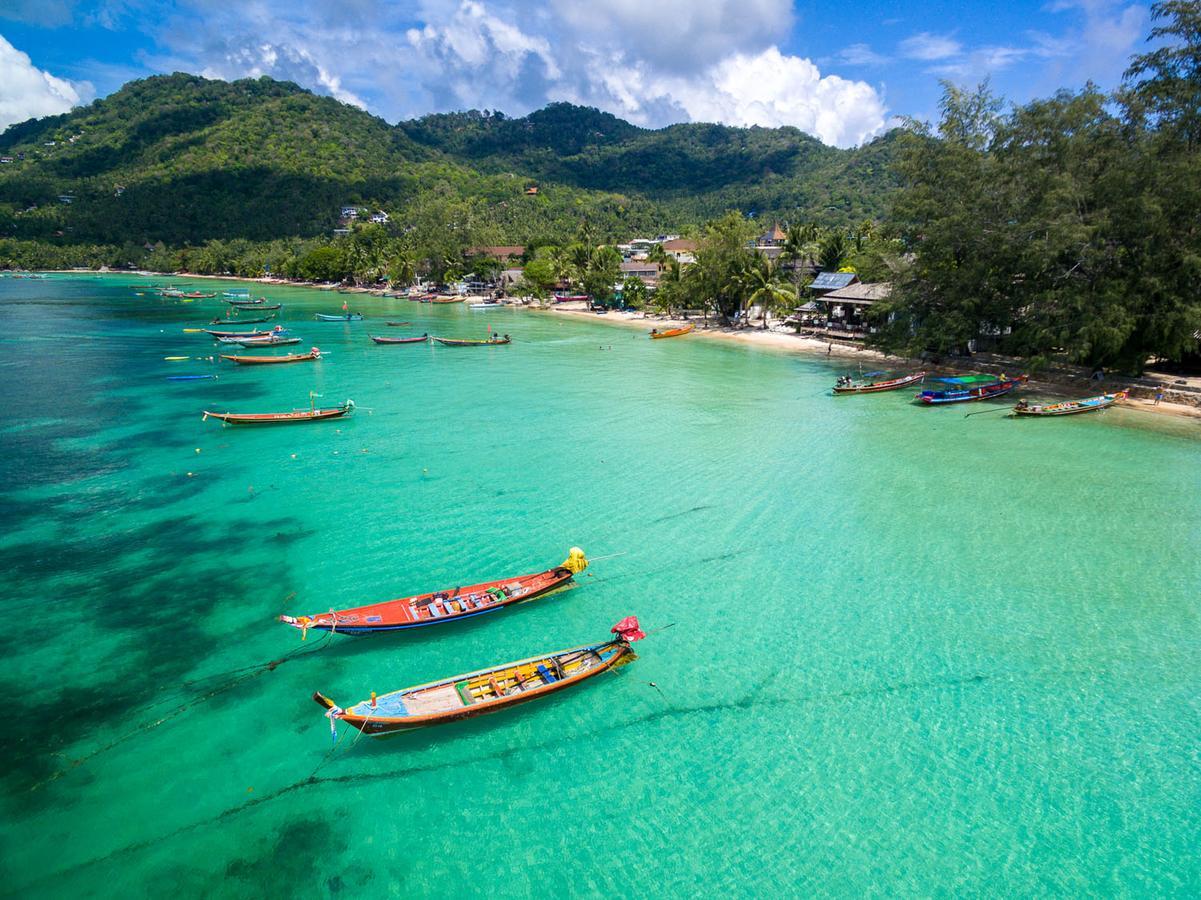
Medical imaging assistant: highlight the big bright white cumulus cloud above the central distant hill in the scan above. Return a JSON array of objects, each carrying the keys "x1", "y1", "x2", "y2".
[{"x1": 408, "y1": 0, "x2": 886, "y2": 147}]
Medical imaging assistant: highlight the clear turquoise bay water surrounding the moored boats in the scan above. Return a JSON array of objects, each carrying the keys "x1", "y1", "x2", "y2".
[{"x1": 0, "y1": 275, "x2": 1201, "y2": 896}]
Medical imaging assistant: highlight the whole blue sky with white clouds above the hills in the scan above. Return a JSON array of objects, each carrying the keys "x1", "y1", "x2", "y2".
[{"x1": 0, "y1": 0, "x2": 1148, "y2": 147}]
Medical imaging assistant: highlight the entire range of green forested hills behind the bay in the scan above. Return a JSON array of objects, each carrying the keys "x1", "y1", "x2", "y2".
[{"x1": 0, "y1": 74, "x2": 894, "y2": 246}]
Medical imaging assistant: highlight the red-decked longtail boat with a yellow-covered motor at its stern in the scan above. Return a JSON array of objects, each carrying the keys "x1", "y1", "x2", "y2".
[{"x1": 280, "y1": 547, "x2": 588, "y2": 636}]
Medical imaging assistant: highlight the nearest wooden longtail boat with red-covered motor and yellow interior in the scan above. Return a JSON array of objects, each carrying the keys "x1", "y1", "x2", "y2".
[{"x1": 312, "y1": 615, "x2": 646, "y2": 735}]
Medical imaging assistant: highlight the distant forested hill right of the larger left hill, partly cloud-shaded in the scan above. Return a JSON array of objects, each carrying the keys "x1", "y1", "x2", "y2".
[{"x1": 400, "y1": 103, "x2": 896, "y2": 225}]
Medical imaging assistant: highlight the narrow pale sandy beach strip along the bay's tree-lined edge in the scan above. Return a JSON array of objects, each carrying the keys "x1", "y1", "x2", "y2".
[{"x1": 18, "y1": 269, "x2": 1201, "y2": 421}]
